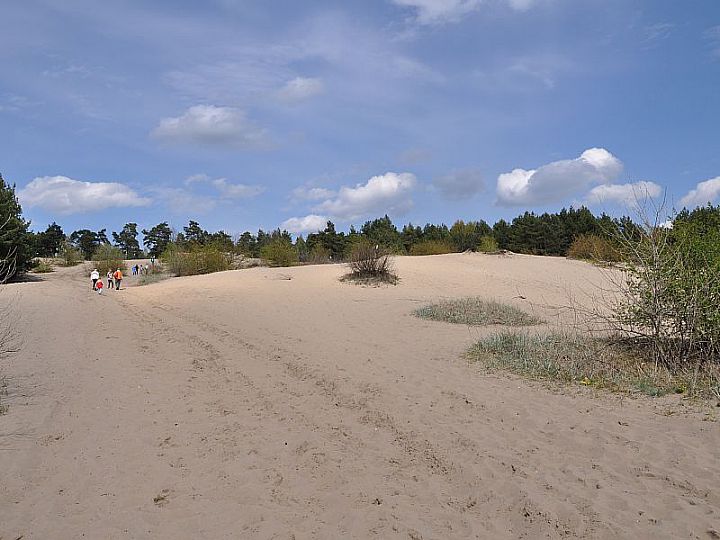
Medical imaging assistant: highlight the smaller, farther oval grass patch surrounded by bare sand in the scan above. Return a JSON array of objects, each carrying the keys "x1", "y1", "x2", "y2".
[{"x1": 413, "y1": 297, "x2": 544, "y2": 326}]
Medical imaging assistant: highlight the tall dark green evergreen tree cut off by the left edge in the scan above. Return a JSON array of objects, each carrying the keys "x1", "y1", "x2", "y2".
[{"x1": 0, "y1": 175, "x2": 33, "y2": 279}]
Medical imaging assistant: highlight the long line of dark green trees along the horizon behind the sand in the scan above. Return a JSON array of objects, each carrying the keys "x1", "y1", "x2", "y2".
[{"x1": 0, "y1": 171, "x2": 720, "y2": 272}]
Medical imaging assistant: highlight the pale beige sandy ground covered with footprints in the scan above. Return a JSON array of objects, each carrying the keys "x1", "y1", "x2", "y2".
[{"x1": 0, "y1": 254, "x2": 720, "y2": 540}]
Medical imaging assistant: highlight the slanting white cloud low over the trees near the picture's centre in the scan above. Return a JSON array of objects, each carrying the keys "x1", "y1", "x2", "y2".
[{"x1": 313, "y1": 172, "x2": 417, "y2": 221}]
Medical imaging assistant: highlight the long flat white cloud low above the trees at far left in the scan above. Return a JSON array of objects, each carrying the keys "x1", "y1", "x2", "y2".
[{"x1": 18, "y1": 176, "x2": 151, "y2": 215}]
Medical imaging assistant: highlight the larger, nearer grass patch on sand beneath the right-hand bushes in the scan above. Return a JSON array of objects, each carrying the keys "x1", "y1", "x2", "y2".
[{"x1": 467, "y1": 331, "x2": 720, "y2": 398}]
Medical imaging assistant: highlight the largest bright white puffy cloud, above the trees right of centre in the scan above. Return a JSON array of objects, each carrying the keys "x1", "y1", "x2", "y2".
[{"x1": 497, "y1": 148, "x2": 623, "y2": 206}]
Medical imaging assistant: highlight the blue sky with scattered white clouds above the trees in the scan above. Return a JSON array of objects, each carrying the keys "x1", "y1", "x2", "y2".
[{"x1": 0, "y1": 0, "x2": 720, "y2": 234}]
